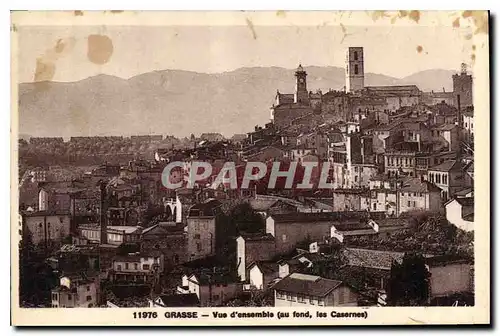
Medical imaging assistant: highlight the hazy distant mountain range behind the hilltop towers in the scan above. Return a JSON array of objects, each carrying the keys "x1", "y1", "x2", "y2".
[{"x1": 19, "y1": 66, "x2": 454, "y2": 137}]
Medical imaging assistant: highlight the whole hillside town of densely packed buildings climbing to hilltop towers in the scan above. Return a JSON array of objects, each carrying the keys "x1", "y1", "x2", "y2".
[{"x1": 18, "y1": 47, "x2": 474, "y2": 308}]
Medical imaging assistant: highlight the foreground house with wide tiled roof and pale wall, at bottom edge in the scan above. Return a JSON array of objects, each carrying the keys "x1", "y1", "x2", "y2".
[{"x1": 273, "y1": 273, "x2": 358, "y2": 307}]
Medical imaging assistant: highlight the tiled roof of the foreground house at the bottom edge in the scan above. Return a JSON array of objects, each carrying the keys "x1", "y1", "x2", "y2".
[{"x1": 274, "y1": 273, "x2": 342, "y2": 297}]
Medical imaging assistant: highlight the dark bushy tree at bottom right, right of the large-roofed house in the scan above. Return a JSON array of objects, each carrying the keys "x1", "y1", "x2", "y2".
[{"x1": 388, "y1": 253, "x2": 430, "y2": 306}]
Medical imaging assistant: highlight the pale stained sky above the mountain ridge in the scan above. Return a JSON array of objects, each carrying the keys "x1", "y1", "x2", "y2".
[{"x1": 17, "y1": 25, "x2": 472, "y2": 82}]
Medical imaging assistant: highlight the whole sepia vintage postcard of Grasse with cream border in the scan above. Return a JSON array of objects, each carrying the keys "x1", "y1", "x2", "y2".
[{"x1": 11, "y1": 10, "x2": 490, "y2": 326}]
